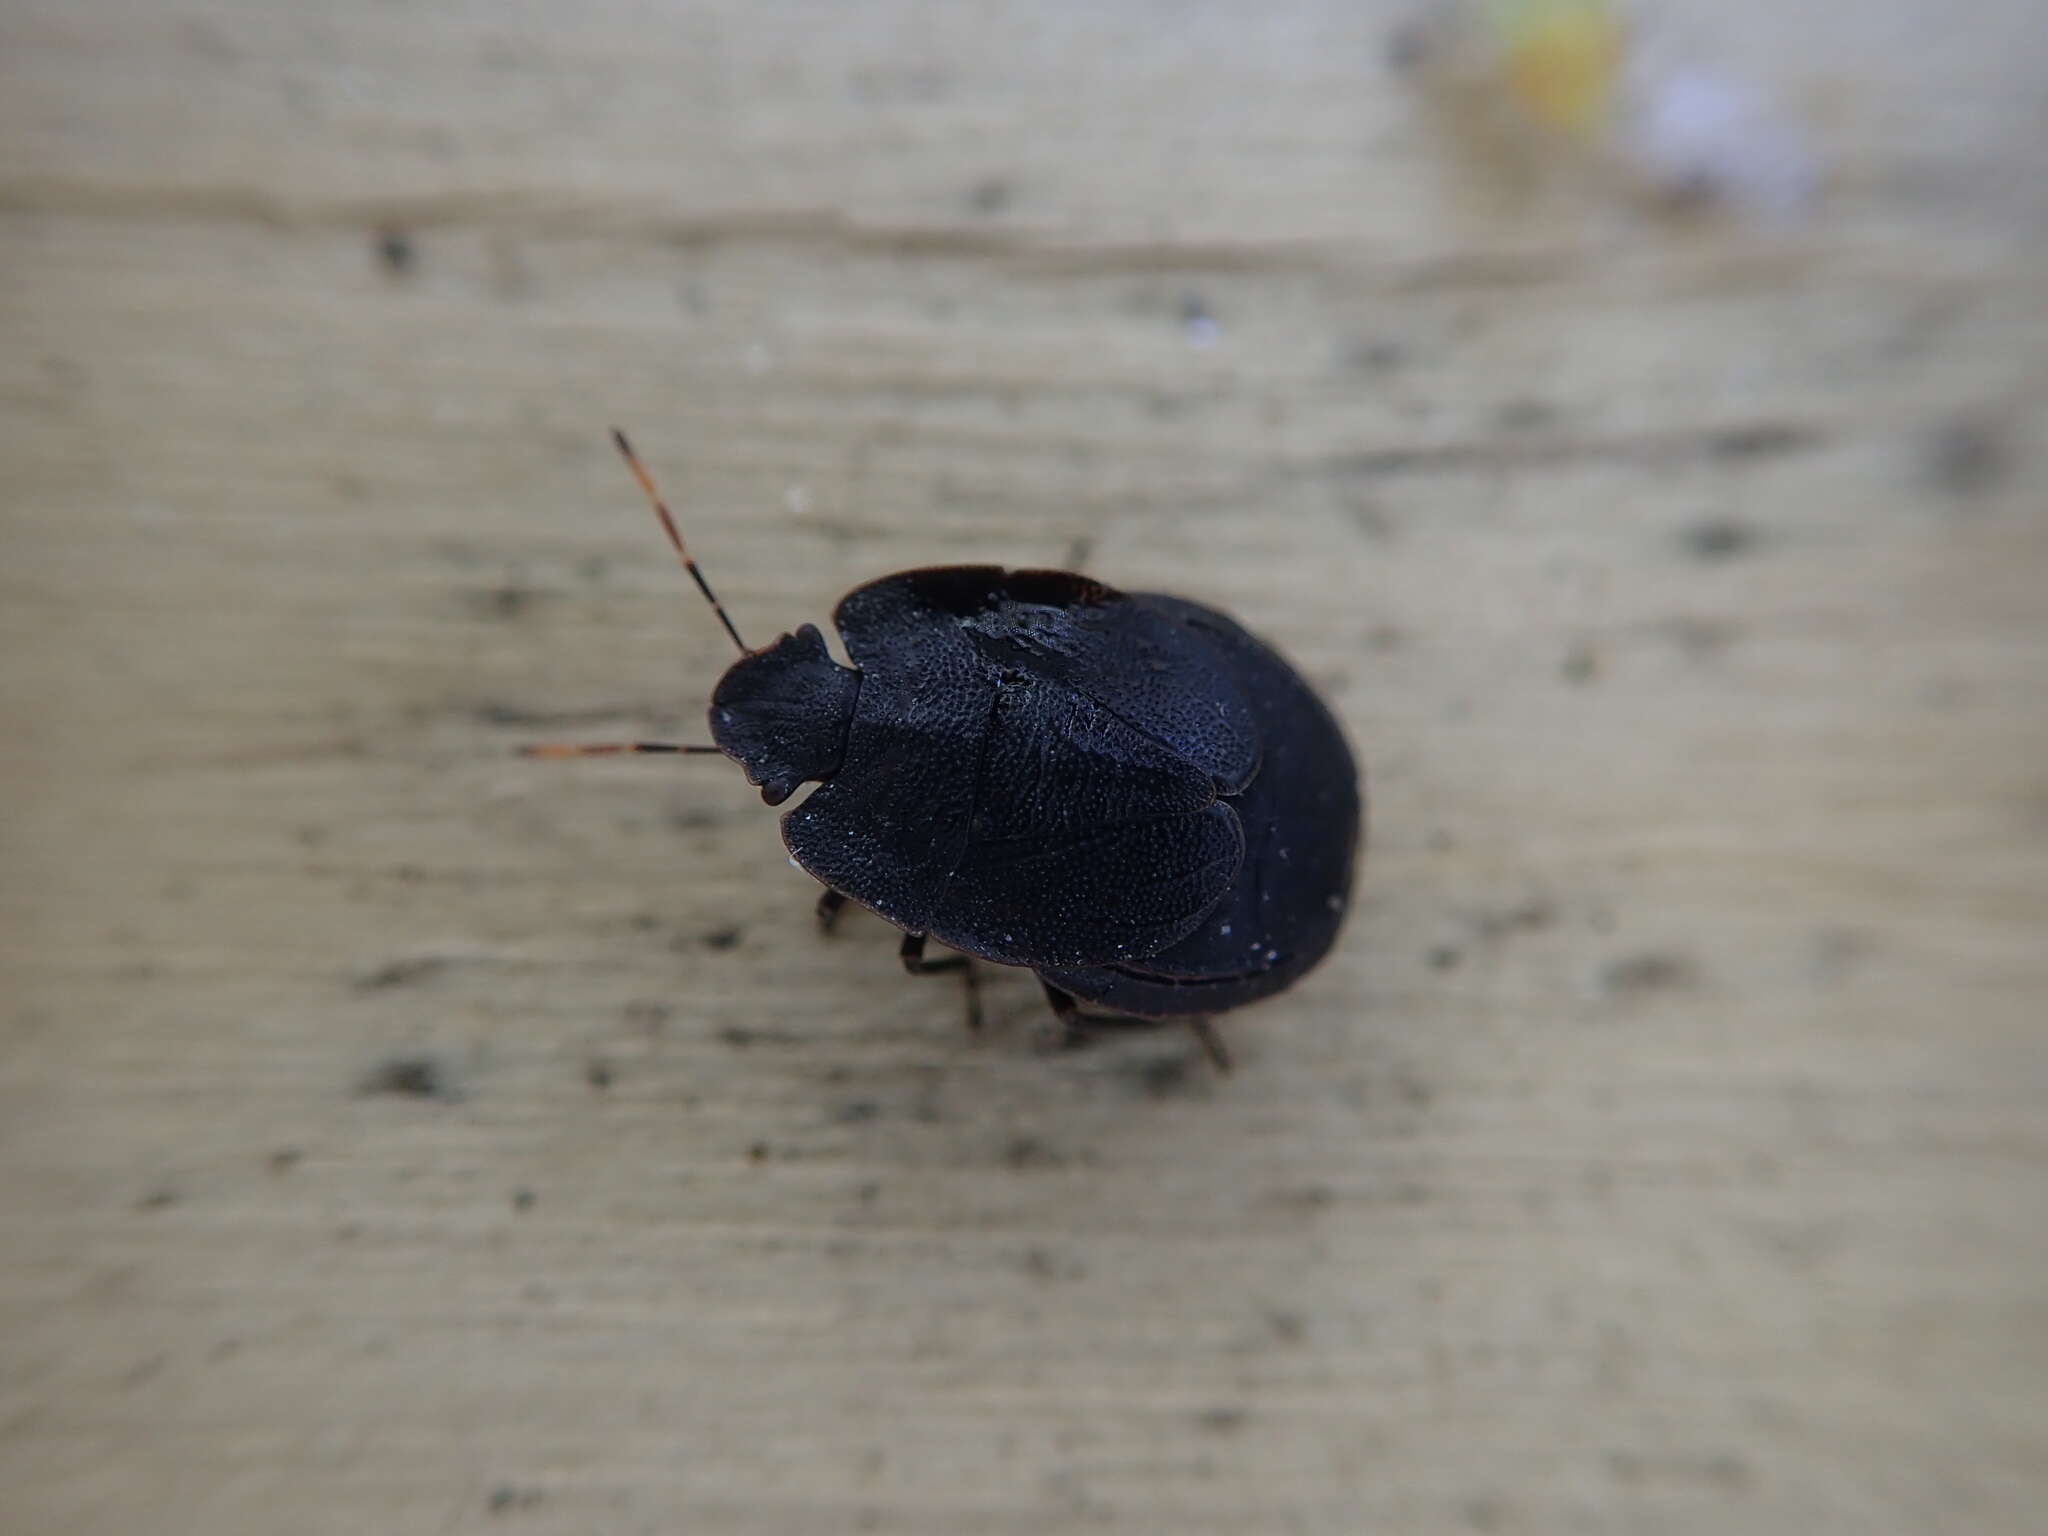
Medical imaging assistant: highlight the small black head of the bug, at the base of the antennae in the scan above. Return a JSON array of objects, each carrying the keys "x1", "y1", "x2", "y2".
[{"x1": 711, "y1": 625, "x2": 860, "y2": 805}]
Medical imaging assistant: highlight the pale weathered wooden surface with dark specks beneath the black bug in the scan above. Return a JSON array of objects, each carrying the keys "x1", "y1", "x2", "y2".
[{"x1": 0, "y1": 0, "x2": 2048, "y2": 1536}]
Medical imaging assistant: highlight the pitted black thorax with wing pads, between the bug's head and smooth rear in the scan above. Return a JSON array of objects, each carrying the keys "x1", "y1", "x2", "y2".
[{"x1": 782, "y1": 565, "x2": 1260, "y2": 967}]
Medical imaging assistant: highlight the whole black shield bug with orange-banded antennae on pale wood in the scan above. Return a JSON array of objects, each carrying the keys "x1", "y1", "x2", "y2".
[{"x1": 528, "y1": 430, "x2": 1360, "y2": 1065}]
